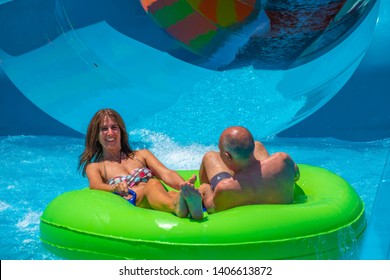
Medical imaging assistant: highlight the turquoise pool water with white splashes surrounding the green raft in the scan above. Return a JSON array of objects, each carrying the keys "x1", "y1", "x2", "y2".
[{"x1": 0, "y1": 135, "x2": 390, "y2": 260}]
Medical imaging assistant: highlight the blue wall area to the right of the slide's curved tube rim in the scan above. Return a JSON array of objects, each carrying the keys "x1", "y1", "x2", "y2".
[{"x1": 280, "y1": 0, "x2": 390, "y2": 141}]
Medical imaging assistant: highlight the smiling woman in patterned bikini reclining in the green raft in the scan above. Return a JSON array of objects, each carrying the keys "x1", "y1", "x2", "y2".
[{"x1": 79, "y1": 109, "x2": 203, "y2": 220}]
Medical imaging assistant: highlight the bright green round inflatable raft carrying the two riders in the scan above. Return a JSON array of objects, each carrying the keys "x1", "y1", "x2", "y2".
[{"x1": 40, "y1": 164, "x2": 366, "y2": 260}]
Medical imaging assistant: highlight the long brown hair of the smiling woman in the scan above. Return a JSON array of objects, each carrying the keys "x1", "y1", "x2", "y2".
[{"x1": 78, "y1": 109, "x2": 133, "y2": 176}]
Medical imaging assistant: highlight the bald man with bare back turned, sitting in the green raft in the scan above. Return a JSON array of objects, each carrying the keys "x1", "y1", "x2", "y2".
[{"x1": 199, "y1": 126, "x2": 299, "y2": 213}]
